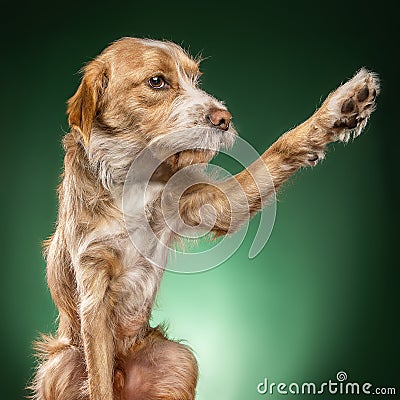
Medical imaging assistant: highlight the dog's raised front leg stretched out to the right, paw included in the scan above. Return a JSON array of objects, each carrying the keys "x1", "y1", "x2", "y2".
[{"x1": 179, "y1": 69, "x2": 379, "y2": 234}]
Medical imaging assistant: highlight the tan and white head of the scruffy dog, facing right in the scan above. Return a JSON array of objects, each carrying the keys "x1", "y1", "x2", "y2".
[{"x1": 68, "y1": 38, "x2": 236, "y2": 186}]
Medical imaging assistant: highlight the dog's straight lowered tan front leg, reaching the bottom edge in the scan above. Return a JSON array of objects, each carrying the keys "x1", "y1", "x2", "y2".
[{"x1": 74, "y1": 245, "x2": 121, "y2": 400}]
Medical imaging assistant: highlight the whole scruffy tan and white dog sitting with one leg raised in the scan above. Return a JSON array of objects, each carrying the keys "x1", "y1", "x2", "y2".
[{"x1": 32, "y1": 38, "x2": 379, "y2": 400}]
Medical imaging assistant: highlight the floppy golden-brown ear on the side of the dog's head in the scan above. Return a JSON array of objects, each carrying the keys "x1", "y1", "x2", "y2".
[{"x1": 67, "y1": 60, "x2": 108, "y2": 146}]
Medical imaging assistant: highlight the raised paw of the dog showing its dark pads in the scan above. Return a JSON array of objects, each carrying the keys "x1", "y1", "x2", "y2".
[{"x1": 321, "y1": 68, "x2": 379, "y2": 142}]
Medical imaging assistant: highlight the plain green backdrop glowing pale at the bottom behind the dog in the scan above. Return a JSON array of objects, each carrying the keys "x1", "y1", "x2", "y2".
[{"x1": 0, "y1": 1, "x2": 400, "y2": 400}]
